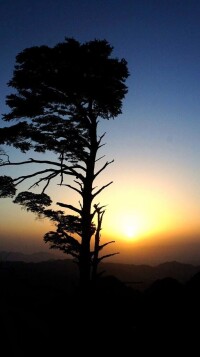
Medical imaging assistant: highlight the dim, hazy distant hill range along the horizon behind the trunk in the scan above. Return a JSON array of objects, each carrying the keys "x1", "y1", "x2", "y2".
[{"x1": 0, "y1": 251, "x2": 200, "y2": 290}]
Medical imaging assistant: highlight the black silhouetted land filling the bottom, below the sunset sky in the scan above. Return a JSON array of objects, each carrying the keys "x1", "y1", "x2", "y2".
[{"x1": 0, "y1": 254, "x2": 200, "y2": 356}]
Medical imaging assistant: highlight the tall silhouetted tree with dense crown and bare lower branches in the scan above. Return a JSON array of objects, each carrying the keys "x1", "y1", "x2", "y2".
[{"x1": 0, "y1": 38, "x2": 129, "y2": 286}]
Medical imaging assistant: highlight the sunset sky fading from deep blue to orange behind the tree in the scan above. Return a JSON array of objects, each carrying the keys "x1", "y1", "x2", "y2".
[{"x1": 0, "y1": 0, "x2": 200, "y2": 264}]
